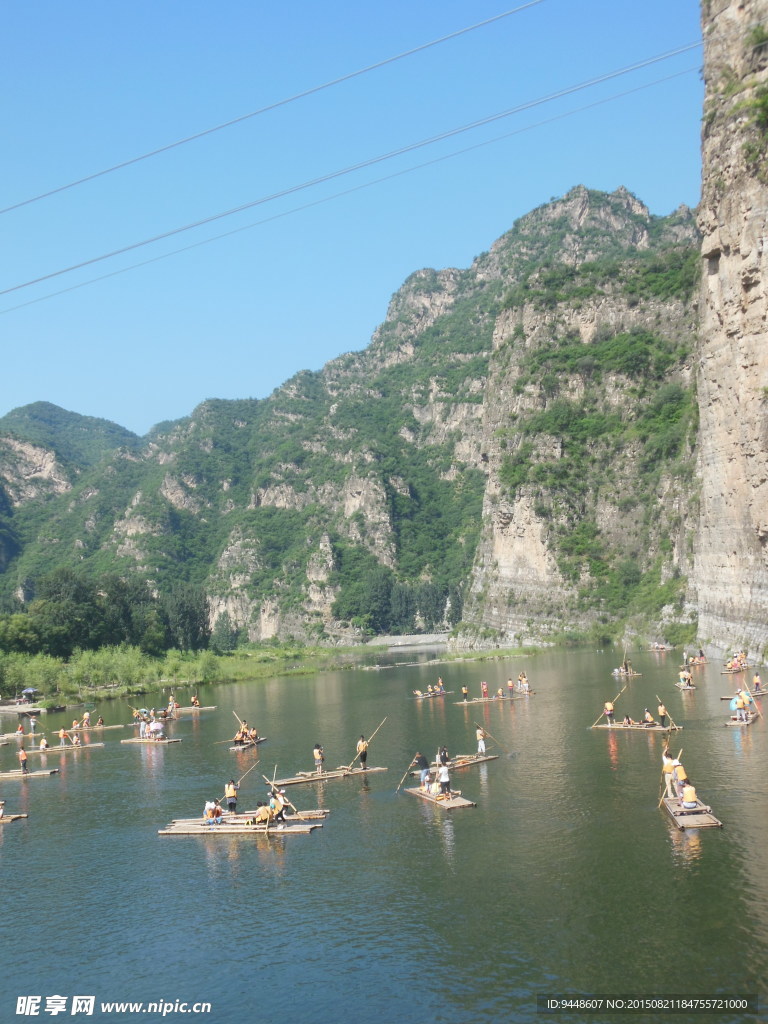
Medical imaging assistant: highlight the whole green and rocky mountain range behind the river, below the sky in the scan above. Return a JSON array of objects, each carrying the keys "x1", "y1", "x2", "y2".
[{"x1": 0, "y1": 186, "x2": 698, "y2": 642}]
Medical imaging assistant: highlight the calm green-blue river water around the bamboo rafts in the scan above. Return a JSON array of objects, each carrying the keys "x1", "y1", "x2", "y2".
[{"x1": 0, "y1": 651, "x2": 768, "y2": 1024}]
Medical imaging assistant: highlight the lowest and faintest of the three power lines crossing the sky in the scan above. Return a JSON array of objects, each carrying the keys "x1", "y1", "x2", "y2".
[{"x1": 0, "y1": 66, "x2": 699, "y2": 316}]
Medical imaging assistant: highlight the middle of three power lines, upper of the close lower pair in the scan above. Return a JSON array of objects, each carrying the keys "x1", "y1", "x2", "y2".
[{"x1": 0, "y1": 42, "x2": 701, "y2": 295}]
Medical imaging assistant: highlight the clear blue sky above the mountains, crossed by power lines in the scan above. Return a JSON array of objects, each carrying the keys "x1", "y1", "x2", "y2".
[{"x1": 0, "y1": 0, "x2": 702, "y2": 434}]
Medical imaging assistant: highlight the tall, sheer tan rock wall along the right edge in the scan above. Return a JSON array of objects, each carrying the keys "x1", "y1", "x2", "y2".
[{"x1": 695, "y1": 0, "x2": 768, "y2": 654}]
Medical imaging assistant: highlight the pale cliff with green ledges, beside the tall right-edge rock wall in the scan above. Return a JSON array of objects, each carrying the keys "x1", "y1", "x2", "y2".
[{"x1": 465, "y1": 187, "x2": 696, "y2": 640}]
